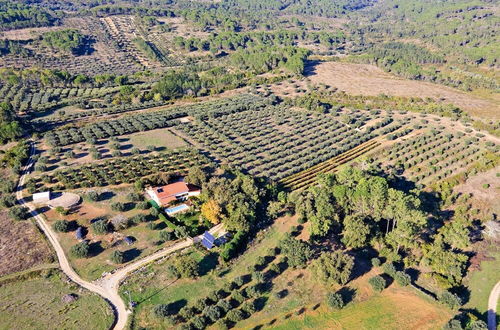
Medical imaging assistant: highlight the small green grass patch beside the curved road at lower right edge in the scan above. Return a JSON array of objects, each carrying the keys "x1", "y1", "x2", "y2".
[{"x1": 466, "y1": 252, "x2": 500, "y2": 314}]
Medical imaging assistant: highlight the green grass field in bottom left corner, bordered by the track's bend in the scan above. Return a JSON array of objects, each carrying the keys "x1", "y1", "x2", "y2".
[{"x1": 0, "y1": 271, "x2": 113, "y2": 330}]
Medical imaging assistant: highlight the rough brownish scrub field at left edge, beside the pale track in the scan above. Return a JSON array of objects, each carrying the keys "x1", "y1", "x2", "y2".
[{"x1": 0, "y1": 211, "x2": 52, "y2": 276}]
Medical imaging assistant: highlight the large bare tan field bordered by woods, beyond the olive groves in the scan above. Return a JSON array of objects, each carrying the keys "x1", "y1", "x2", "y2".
[{"x1": 306, "y1": 62, "x2": 500, "y2": 119}]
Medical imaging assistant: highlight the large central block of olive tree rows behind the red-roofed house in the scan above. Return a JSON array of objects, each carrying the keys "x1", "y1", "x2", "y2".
[{"x1": 176, "y1": 105, "x2": 406, "y2": 180}]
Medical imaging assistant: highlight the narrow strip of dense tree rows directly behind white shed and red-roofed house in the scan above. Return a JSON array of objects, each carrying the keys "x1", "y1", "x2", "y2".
[{"x1": 34, "y1": 149, "x2": 210, "y2": 190}]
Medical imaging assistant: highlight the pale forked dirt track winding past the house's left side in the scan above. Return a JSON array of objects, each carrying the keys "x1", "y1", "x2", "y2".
[{"x1": 16, "y1": 143, "x2": 222, "y2": 330}]
